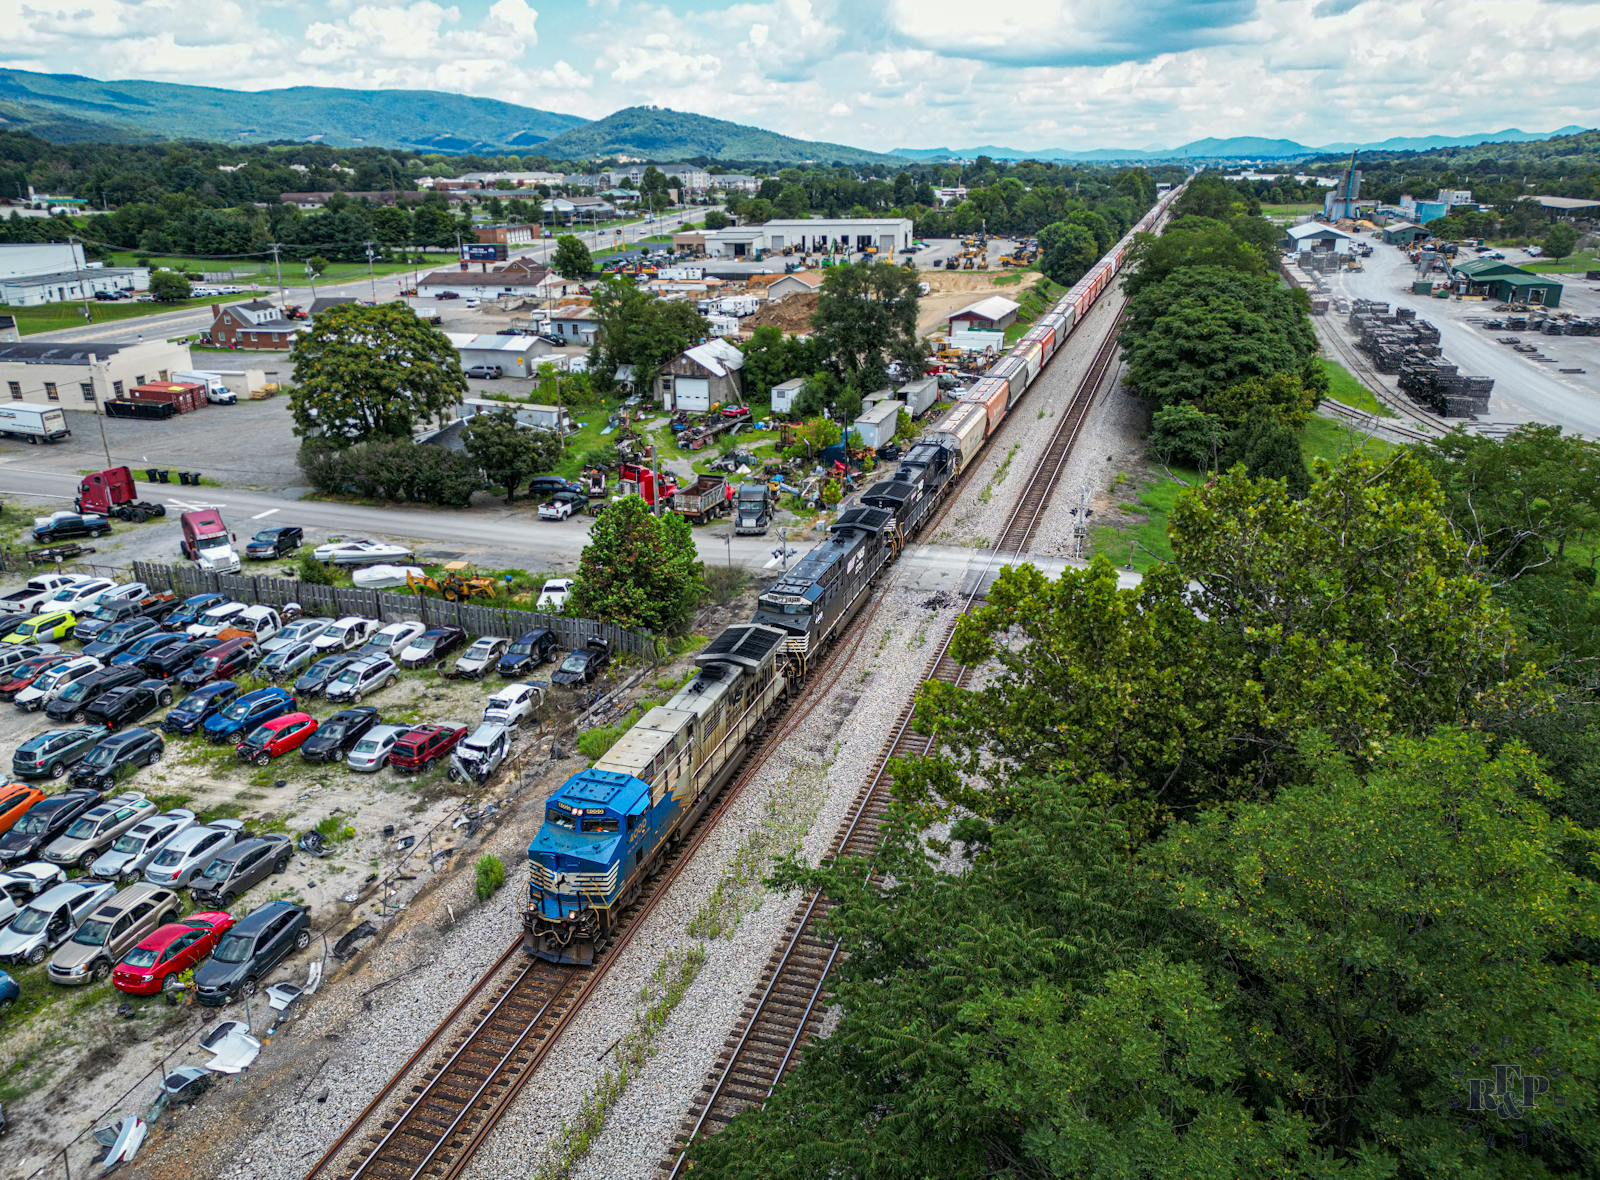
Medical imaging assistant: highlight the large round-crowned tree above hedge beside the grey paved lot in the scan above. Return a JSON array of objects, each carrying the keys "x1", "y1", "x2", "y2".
[{"x1": 290, "y1": 304, "x2": 467, "y2": 446}]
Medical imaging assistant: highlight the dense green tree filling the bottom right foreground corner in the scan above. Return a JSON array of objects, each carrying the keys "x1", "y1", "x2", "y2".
[{"x1": 691, "y1": 734, "x2": 1600, "y2": 1180}]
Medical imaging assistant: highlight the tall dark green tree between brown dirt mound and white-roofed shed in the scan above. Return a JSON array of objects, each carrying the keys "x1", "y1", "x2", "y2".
[{"x1": 811, "y1": 262, "x2": 926, "y2": 393}]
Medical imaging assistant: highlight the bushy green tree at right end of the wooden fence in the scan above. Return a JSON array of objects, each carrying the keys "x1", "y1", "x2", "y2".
[{"x1": 566, "y1": 496, "x2": 706, "y2": 635}]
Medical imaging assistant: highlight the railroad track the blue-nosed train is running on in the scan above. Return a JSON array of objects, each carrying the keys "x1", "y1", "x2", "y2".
[{"x1": 306, "y1": 596, "x2": 882, "y2": 1180}]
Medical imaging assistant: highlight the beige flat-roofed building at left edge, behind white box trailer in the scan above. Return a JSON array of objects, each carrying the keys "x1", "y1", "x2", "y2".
[{"x1": 0, "y1": 341, "x2": 194, "y2": 413}]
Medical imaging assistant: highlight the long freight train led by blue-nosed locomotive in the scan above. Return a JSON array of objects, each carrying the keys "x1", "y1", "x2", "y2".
[{"x1": 523, "y1": 181, "x2": 1182, "y2": 964}]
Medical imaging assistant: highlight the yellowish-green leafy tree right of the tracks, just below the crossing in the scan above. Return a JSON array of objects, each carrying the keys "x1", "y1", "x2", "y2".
[{"x1": 896, "y1": 454, "x2": 1515, "y2": 828}]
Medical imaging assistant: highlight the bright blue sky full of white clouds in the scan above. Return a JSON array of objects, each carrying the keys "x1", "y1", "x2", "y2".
[{"x1": 0, "y1": 0, "x2": 1600, "y2": 150}]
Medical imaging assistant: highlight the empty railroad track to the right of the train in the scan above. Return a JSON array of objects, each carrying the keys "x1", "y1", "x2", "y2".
[{"x1": 659, "y1": 284, "x2": 1122, "y2": 1180}]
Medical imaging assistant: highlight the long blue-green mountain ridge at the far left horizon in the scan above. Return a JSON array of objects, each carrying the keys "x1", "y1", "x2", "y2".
[{"x1": 0, "y1": 69, "x2": 587, "y2": 153}]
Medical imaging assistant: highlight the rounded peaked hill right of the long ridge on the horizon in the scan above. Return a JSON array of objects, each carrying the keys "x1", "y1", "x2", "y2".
[{"x1": 539, "y1": 107, "x2": 894, "y2": 165}]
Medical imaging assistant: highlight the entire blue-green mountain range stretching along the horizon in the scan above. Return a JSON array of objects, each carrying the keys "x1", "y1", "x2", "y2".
[{"x1": 0, "y1": 69, "x2": 1582, "y2": 165}]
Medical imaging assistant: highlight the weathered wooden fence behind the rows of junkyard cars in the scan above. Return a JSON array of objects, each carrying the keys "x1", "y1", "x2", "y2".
[{"x1": 133, "y1": 561, "x2": 653, "y2": 656}]
